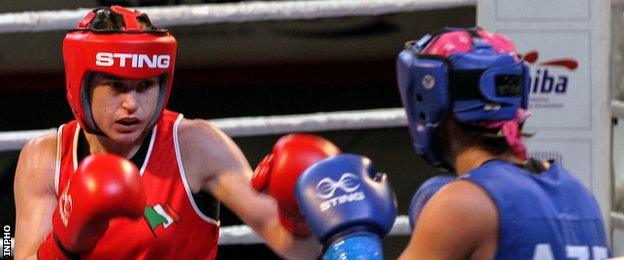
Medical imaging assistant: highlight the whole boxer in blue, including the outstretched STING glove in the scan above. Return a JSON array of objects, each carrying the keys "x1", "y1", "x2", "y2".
[{"x1": 296, "y1": 28, "x2": 610, "y2": 259}]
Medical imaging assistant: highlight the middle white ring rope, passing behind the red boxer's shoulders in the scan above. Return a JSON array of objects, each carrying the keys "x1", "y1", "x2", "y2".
[{"x1": 0, "y1": 108, "x2": 407, "y2": 151}]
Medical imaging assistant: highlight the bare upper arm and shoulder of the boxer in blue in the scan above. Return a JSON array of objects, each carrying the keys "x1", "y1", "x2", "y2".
[{"x1": 400, "y1": 180, "x2": 498, "y2": 259}]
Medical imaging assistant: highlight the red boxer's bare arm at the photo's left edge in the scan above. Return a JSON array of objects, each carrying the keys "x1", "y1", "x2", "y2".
[{"x1": 14, "y1": 134, "x2": 57, "y2": 259}]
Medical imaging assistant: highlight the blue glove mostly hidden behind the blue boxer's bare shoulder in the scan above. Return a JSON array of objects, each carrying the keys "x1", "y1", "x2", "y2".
[{"x1": 409, "y1": 175, "x2": 457, "y2": 230}]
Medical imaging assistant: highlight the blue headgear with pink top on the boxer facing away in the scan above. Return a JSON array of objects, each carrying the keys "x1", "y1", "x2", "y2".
[{"x1": 397, "y1": 28, "x2": 530, "y2": 166}]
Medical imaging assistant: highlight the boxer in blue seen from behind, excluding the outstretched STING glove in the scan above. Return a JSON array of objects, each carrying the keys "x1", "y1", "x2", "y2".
[{"x1": 397, "y1": 28, "x2": 610, "y2": 259}]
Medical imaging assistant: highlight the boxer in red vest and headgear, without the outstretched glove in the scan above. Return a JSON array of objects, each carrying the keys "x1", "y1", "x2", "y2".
[{"x1": 15, "y1": 6, "x2": 322, "y2": 259}]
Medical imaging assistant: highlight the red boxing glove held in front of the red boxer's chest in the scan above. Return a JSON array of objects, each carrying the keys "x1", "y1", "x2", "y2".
[{"x1": 37, "y1": 154, "x2": 145, "y2": 259}]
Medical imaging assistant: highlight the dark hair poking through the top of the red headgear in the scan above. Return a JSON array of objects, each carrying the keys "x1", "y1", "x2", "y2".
[{"x1": 88, "y1": 7, "x2": 163, "y2": 32}]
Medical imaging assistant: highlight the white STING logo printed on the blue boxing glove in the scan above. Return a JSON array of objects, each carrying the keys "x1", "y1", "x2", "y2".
[{"x1": 316, "y1": 172, "x2": 366, "y2": 211}]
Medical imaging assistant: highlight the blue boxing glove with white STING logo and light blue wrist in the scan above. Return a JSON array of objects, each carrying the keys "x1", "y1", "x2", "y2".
[{"x1": 295, "y1": 154, "x2": 397, "y2": 259}]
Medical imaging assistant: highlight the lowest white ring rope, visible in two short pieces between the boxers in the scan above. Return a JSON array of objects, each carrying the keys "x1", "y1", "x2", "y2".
[{"x1": 219, "y1": 216, "x2": 412, "y2": 245}]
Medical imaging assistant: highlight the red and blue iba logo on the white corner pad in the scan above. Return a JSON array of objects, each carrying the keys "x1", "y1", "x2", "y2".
[{"x1": 522, "y1": 51, "x2": 579, "y2": 109}]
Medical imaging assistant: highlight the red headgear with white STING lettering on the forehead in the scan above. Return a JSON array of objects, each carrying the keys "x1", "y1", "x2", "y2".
[{"x1": 63, "y1": 6, "x2": 177, "y2": 134}]
